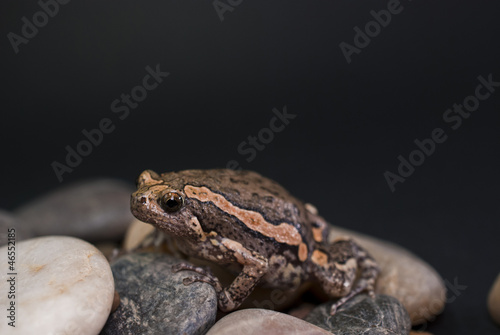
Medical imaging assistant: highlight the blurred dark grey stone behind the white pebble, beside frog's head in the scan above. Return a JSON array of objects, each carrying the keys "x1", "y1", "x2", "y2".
[{"x1": 15, "y1": 179, "x2": 133, "y2": 243}]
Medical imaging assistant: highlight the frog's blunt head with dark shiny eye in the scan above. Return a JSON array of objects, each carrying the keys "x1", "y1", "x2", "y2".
[{"x1": 130, "y1": 170, "x2": 193, "y2": 237}]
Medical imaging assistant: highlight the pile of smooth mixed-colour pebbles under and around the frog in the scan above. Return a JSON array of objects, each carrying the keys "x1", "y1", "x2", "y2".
[{"x1": 0, "y1": 179, "x2": 494, "y2": 335}]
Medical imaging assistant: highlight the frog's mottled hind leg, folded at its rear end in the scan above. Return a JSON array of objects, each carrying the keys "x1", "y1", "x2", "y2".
[{"x1": 311, "y1": 239, "x2": 380, "y2": 315}]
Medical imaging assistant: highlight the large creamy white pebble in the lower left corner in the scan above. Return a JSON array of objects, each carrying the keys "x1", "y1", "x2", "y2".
[{"x1": 0, "y1": 236, "x2": 114, "y2": 335}]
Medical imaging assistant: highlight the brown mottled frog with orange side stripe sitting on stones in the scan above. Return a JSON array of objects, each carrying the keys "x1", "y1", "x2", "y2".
[{"x1": 130, "y1": 169, "x2": 380, "y2": 315}]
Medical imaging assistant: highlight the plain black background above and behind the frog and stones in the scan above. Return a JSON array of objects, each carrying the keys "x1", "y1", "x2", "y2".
[{"x1": 0, "y1": 0, "x2": 500, "y2": 334}]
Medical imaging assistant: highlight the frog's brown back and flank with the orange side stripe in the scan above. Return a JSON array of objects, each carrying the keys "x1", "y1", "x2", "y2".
[{"x1": 161, "y1": 169, "x2": 312, "y2": 262}]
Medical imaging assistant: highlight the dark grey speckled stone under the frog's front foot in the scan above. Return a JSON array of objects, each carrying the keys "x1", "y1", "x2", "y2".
[{"x1": 101, "y1": 253, "x2": 217, "y2": 335}]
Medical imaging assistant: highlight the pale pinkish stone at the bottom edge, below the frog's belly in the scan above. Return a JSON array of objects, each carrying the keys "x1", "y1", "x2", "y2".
[{"x1": 207, "y1": 308, "x2": 332, "y2": 335}]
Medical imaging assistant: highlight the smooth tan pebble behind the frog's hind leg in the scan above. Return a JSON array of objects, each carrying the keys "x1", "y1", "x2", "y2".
[{"x1": 329, "y1": 226, "x2": 446, "y2": 325}]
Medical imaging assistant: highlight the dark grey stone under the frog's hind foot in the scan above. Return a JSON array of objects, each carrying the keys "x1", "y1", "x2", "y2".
[{"x1": 305, "y1": 295, "x2": 411, "y2": 335}]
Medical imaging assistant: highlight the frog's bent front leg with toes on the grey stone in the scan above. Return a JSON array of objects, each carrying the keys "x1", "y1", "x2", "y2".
[{"x1": 173, "y1": 236, "x2": 268, "y2": 312}]
